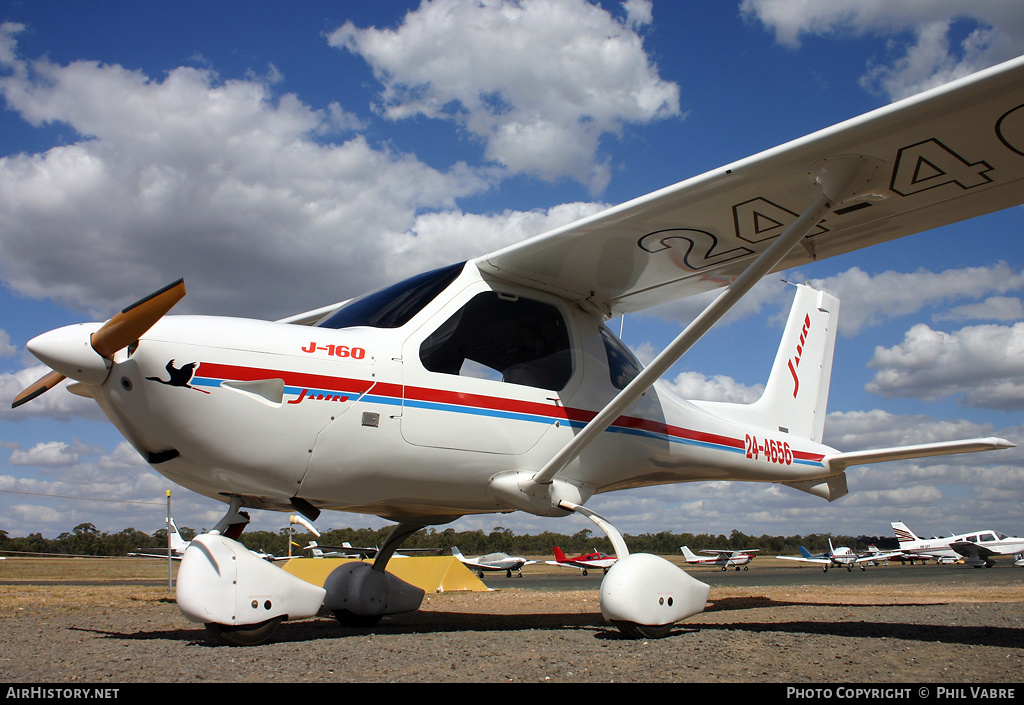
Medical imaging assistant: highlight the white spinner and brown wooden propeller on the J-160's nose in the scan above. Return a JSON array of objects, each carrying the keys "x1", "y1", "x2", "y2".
[{"x1": 11, "y1": 279, "x2": 185, "y2": 409}]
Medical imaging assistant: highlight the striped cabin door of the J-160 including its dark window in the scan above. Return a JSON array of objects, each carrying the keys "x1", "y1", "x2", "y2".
[{"x1": 401, "y1": 282, "x2": 582, "y2": 454}]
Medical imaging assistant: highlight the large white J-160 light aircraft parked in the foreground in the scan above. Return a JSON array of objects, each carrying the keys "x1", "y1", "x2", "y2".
[{"x1": 13, "y1": 57, "x2": 1024, "y2": 645}]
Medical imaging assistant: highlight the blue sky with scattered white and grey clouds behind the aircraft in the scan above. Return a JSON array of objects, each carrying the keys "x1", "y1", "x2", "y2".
[{"x1": 0, "y1": 0, "x2": 1024, "y2": 537}]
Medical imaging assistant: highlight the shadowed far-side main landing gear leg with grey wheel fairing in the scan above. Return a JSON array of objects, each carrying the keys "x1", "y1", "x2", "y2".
[{"x1": 324, "y1": 523, "x2": 427, "y2": 627}]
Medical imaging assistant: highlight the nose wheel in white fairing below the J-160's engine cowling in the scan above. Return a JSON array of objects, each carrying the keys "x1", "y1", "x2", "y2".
[{"x1": 177, "y1": 497, "x2": 326, "y2": 647}]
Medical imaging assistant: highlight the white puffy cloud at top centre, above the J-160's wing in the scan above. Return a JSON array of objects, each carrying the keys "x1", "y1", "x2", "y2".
[{"x1": 329, "y1": 0, "x2": 680, "y2": 193}]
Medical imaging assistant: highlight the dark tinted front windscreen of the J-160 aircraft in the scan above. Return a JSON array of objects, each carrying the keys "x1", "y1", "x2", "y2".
[{"x1": 316, "y1": 262, "x2": 465, "y2": 328}]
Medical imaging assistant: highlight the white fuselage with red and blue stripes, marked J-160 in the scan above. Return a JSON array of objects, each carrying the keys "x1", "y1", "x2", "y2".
[{"x1": 90, "y1": 261, "x2": 833, "y2": 520}]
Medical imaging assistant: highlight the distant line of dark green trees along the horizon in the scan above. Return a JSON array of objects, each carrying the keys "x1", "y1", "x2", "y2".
[{"x1": 0, "y1": 524, "x2": 899, "y2": 556}]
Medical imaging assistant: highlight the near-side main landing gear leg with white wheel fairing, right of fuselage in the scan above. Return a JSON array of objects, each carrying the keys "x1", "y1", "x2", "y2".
[{"x1": 559, "y1": 501, "x2": 711, "y2": 638}]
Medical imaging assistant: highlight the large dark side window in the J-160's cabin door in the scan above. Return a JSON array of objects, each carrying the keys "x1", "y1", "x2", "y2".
[{"x1": 420, "y1": 291, "x2": 572, "y2": 391}]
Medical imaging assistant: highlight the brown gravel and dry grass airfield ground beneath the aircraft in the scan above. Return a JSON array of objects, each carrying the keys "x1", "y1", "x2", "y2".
[{"x1": 0, "y1": 558, "x2": 1024, "y2": 684}]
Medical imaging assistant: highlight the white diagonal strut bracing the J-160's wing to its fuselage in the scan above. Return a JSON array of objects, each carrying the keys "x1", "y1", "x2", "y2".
[{"x1": 523, "y1": 194, "x2": 833, "y2": 494}]
